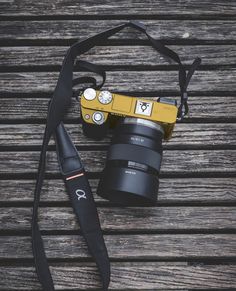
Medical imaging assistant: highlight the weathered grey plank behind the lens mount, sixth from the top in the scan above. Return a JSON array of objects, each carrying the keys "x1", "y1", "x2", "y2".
[{"x1": 0, "y1": 123, "x2": 236, "y2": 149}]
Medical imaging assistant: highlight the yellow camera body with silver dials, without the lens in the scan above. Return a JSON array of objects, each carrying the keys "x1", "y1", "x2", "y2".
[{"x1": 80, "y1": 88, "x2": 178, "y2": 140}]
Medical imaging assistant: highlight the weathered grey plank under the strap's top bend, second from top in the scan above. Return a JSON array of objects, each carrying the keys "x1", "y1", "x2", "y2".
[{"x1": 0, "y1": 20, "x2": 236, "y2": 44}]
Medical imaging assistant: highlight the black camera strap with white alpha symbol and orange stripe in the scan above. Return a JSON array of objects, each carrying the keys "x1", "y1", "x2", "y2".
[{"x1": 32, "y1": 21, "x2": 201, "y2": 291}]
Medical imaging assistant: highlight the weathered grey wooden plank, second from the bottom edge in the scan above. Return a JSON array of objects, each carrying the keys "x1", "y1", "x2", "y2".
[{"x1": 0, "y1": 234, "x2": 236, "y2": 260}]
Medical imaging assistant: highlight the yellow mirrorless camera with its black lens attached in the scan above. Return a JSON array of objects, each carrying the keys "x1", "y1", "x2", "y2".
[{"x1": 81, "y1": 88, "x2": 178, "y2": 206}]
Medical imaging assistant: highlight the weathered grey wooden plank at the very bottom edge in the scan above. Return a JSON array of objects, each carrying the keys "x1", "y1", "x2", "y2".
[{"x1": 0, "y1": 262, "x2": 236, "y2": 291}]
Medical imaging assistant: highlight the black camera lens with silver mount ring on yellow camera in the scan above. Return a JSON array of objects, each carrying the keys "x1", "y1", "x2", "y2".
[{"x1": 97, "y1": 118, "x2": 164, "y2": 206}]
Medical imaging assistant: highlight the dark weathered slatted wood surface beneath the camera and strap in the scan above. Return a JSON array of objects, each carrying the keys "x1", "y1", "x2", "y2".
[{"x1": 0, "y1": 0, "x2": 236, "y2": 291}]
